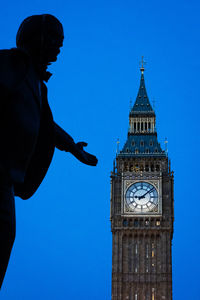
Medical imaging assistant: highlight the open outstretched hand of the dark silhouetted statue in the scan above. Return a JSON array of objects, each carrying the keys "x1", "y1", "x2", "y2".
[{"x1": 71, "y1": 142, "x2": 98, "y2": 166}]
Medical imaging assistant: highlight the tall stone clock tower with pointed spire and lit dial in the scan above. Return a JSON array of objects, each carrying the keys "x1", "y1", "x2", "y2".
[{"x1": 111, "y1": 64, "x2": 174, "y2": 300}]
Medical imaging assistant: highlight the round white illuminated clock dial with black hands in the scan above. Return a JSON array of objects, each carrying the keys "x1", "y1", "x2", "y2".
[{"x1": 125, "y1": 182, "x2": 158, "y2": 213}]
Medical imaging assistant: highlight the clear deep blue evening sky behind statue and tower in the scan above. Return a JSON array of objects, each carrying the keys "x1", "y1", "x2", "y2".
[{"x1": 0, "y1": 0, "x2": 200, "y2": 300}]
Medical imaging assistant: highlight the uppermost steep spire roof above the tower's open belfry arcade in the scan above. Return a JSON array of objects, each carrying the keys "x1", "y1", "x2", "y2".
[{"x1": 131, "y1": 73, "x2": 154, "y2": 114}]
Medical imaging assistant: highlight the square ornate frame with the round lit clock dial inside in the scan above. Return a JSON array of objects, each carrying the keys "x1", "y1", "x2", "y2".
[{"x1": 122, "y1": 179, "x2": 162, "y2": 216}]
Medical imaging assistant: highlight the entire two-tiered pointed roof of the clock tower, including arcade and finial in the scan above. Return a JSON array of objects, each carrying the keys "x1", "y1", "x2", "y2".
[{"x1": 117, "y1": 62, "x2": 166, "y2": 158}]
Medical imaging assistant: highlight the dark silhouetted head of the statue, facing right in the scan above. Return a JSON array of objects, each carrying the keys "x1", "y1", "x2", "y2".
[{"x1": 16, "y1": 14, "x2": 64, "y2": 66}]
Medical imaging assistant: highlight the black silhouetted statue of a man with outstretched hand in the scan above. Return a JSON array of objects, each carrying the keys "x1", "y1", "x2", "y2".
[{"x1": 0, "y1": 15, "x2": 97, "y2": 286}]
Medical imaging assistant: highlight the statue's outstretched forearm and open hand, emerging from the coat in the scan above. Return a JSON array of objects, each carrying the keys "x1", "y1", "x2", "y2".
[{"x1": 54, "y1": 123, "x2": 98, "y2": 166}]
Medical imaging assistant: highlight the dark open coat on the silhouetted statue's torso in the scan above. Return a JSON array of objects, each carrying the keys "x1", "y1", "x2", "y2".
[{"x1": 0, "y1": 49, "x2": 55, "y2": 199}]
